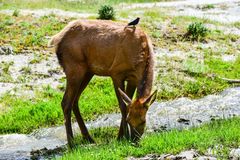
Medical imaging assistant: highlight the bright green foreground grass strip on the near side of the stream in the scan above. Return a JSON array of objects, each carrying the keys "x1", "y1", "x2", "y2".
[{"x1": 60, "y1": 117, "x2": 240, "y2": 160}]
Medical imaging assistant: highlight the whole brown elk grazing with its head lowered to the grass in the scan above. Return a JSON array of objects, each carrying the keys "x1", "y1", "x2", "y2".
[{"x1": 49, "y1": 20, "x2": 156, "y2": 147}]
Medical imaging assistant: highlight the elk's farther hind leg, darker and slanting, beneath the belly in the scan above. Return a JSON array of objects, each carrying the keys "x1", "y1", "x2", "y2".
[{"x1": 73, "y1": 73, "x2": 94, "y2": 143}]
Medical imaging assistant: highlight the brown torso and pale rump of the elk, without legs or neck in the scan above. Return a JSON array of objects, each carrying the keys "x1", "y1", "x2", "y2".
[{"x1": 51, "y1": 20, "x2": 153, "y2": 76}]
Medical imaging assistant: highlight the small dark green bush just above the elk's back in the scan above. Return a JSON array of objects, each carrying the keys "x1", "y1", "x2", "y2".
[{"x1": 98, "y1": 5, "x2": 115, "y2": 20}]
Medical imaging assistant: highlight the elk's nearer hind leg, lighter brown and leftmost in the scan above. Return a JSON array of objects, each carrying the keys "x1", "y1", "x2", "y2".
[{"x1": 62, "y1": 67, "x2": 86, "y2": 148}]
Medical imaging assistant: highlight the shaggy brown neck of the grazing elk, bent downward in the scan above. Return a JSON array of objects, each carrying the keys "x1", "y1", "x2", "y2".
[{"x1": 137, "y1": 52, "x2": 153, "y2": 98}]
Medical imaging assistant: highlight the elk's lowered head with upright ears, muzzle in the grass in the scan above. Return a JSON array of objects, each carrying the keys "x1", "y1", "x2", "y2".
[{"x1": 119, "y1": 89, "x2": 157, "y2": 141}]
